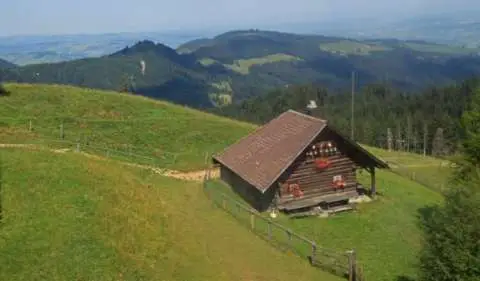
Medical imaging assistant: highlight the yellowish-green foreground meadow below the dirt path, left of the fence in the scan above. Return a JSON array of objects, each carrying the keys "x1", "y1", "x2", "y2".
[{"x1": 0, "y1": 149, "x2": 339, "y2": 281}]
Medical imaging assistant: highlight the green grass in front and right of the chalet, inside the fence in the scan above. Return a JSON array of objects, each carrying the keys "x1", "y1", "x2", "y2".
[{"x1": 210, "y1": 147, "x2": 448, "y2": 280}]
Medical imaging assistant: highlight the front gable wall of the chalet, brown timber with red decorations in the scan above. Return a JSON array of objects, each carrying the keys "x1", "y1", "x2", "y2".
[{"x1": 273, "y1": 127, "x2": 375, "y2": 210}]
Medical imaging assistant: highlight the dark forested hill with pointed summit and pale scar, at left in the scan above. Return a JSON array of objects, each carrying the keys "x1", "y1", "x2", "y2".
[{"x1": 0, "y1": 41, "x2": 233, "y2": 107}]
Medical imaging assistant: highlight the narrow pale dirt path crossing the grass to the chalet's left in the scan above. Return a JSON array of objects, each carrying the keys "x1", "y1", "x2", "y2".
[{"x1": 0, "y1": 143, "x2": 220, "y2": 182}]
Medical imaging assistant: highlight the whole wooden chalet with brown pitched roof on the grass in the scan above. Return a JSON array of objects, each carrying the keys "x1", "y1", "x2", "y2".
[{"x1": 213, "y1": 110, "x2": 388, "y2": 212}]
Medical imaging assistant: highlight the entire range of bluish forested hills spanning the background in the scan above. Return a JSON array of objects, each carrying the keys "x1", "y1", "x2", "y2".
[{"x1": 0, "y1": 30, "x2": 480, "y2": 107}]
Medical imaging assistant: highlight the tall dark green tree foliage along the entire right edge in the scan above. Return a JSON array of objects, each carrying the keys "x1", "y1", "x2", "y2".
[{"x1": 420, "y1": 87, "x2": 480, "y2": 281}]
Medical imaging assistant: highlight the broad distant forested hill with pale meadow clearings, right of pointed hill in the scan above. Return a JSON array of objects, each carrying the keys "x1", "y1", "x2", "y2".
[{"x1": 177, "y1": 30, "x2": 480, "y2": 101}]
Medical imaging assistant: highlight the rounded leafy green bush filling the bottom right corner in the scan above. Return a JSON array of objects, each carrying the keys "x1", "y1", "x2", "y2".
[{"x1": 420, "y1": 172, "x2": 480, "y2": 281}]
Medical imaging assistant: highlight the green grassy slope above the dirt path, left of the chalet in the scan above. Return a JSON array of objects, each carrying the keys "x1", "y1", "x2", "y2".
[{"x1": 0, "y1": 84, "x2": 254, "y2": 170}]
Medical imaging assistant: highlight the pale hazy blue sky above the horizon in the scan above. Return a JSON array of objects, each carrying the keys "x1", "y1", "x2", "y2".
[{"x1": 0, "y1": 0, "x2": 480, "y2": 36}]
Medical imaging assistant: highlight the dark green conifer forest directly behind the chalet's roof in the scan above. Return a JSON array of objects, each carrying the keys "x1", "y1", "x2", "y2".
[{"x1": 212, "y1": 79, "x2": 480, "y2": 155}]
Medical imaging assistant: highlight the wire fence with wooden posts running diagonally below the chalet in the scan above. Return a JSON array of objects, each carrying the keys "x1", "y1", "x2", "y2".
[{"x1": 203, "y1": 168, "x2": 364, "y2": 281}]
